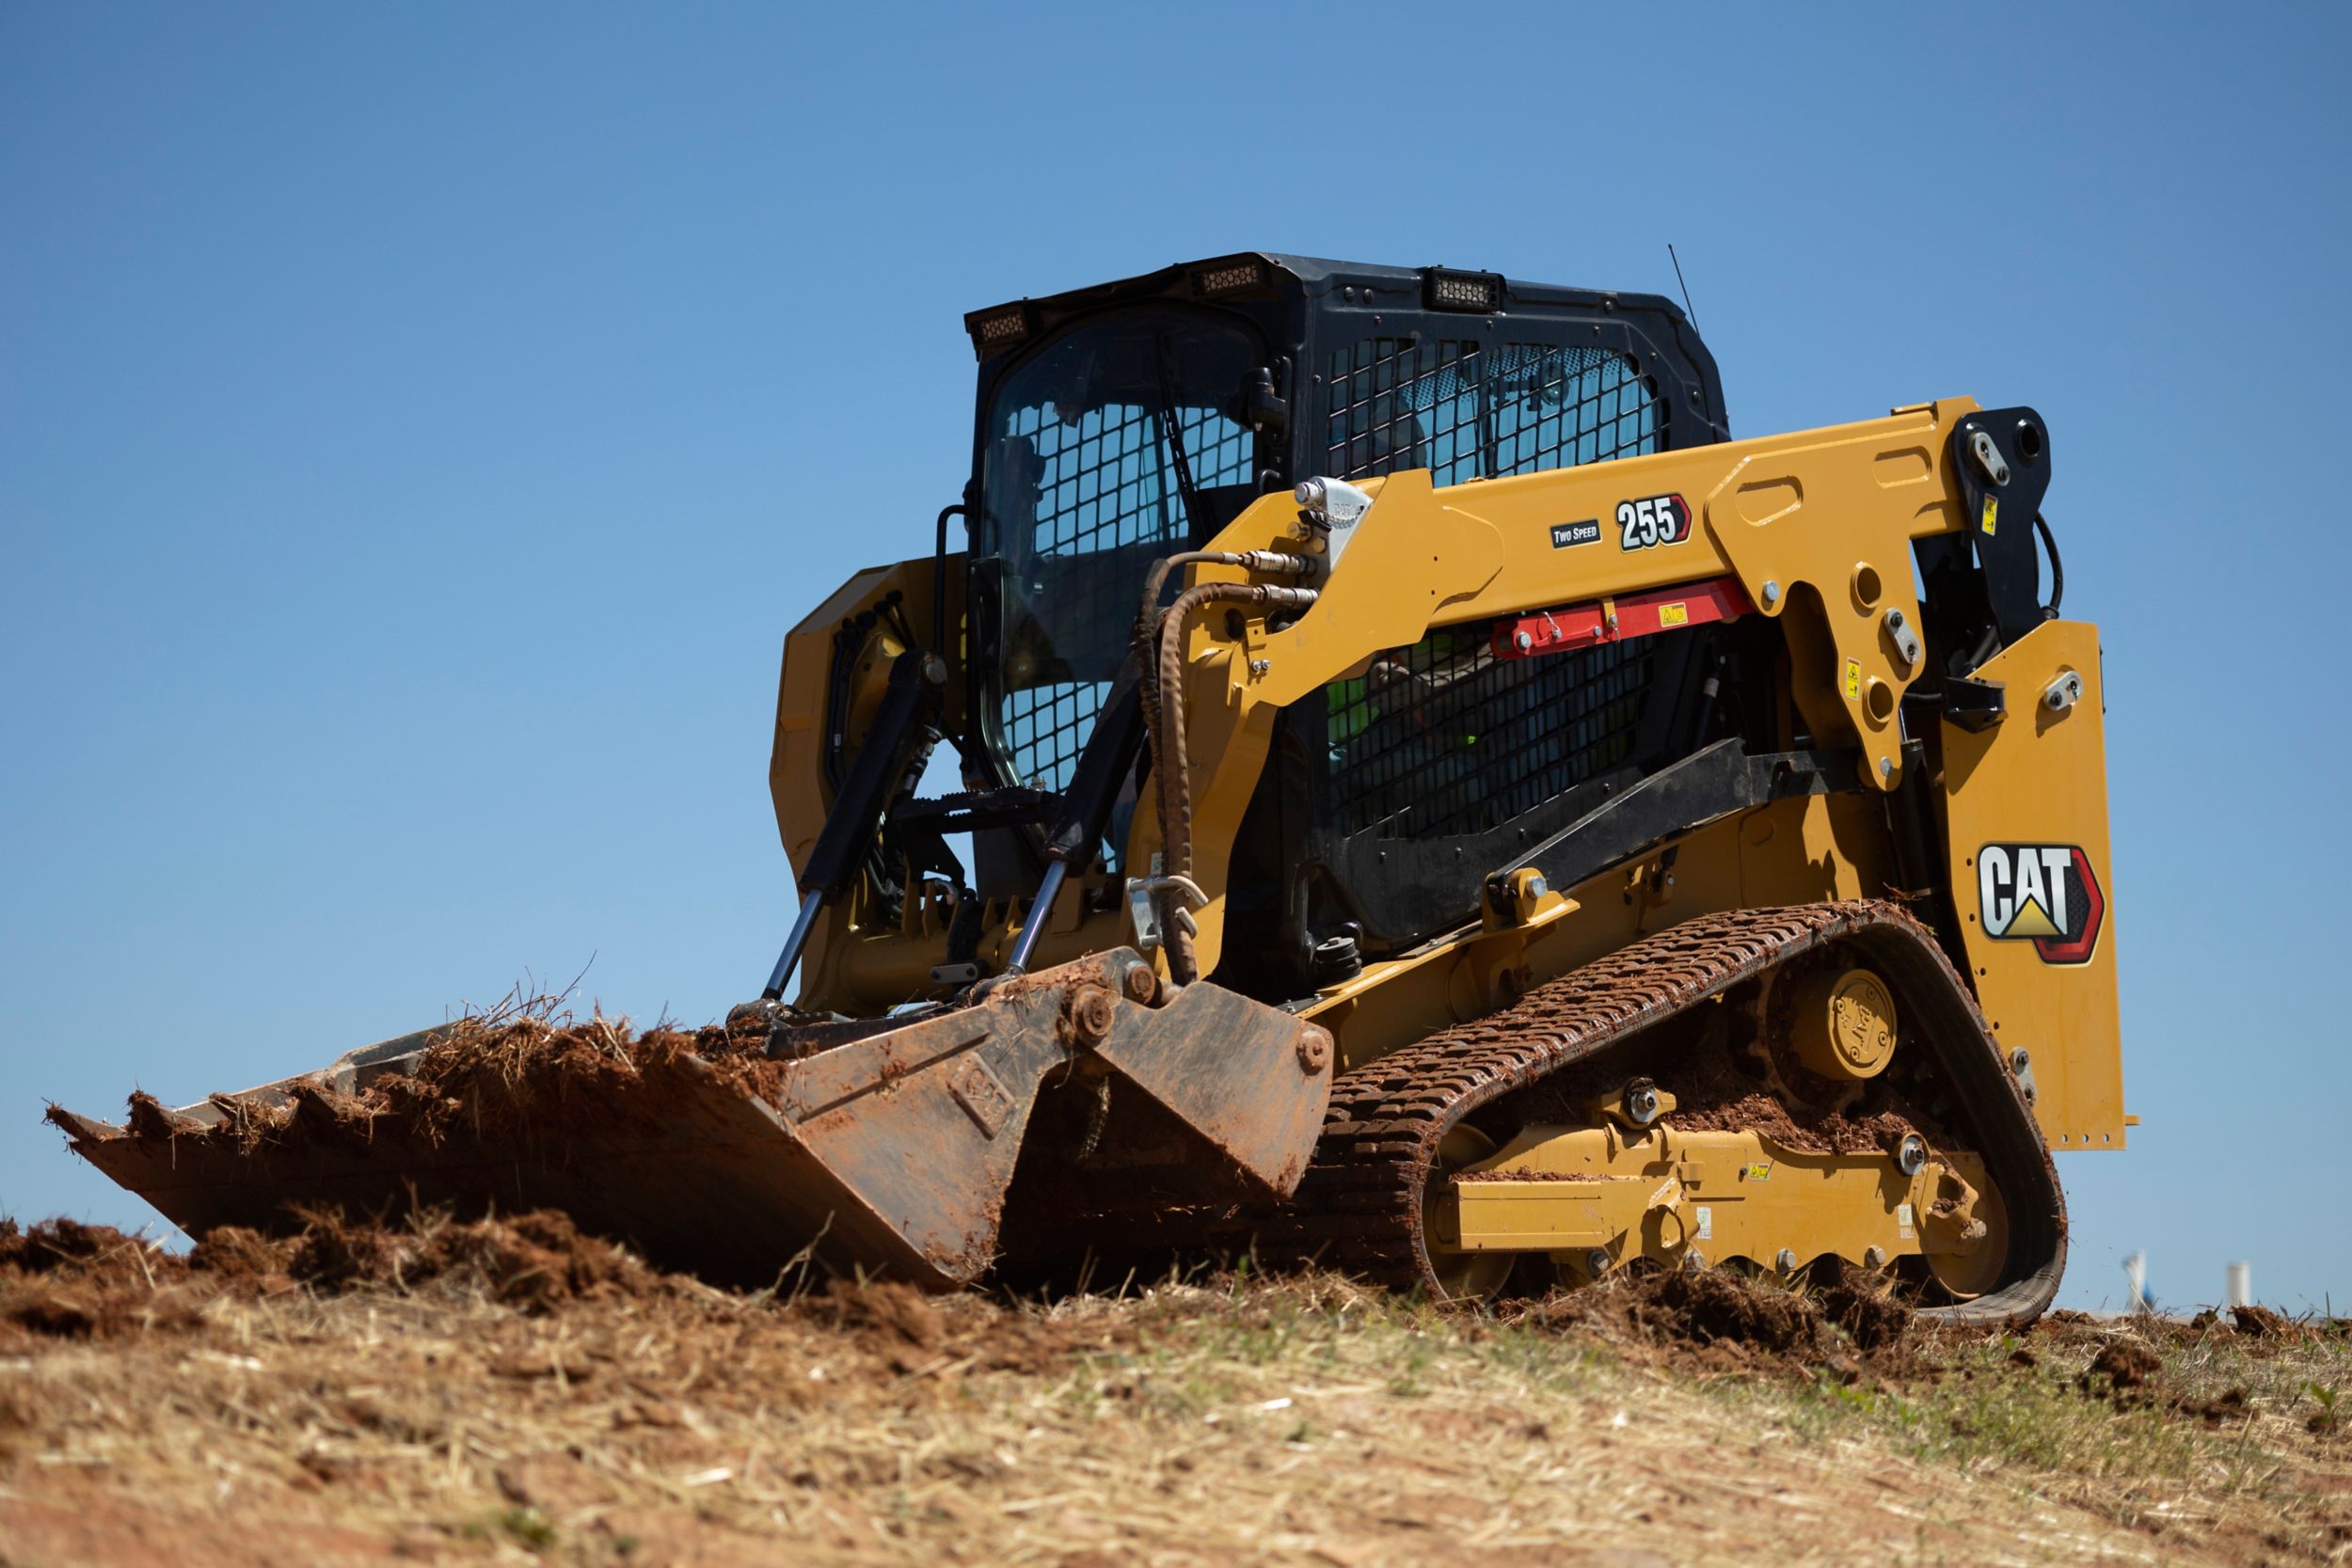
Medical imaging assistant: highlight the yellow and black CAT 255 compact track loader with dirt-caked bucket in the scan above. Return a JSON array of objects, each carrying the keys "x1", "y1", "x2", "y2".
[{"x1": 55, "y1": 254, "x2": 2131, "y2": 1322}]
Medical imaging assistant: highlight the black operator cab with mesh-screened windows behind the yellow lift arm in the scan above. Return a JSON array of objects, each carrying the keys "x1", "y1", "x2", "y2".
[{"x1": 958, "y1": 254, "x2": 1729, "y2": 994}]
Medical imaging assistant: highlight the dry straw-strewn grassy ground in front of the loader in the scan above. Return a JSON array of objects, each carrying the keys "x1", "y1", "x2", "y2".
[{"x1": 0, "y1": 1227, "x2": 2352, "y2": 1568}]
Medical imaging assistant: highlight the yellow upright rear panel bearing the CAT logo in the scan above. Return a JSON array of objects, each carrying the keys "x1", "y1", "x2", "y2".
[{"x1": 1943, "y1": 621, "x2": 2124, "y2": 1149}]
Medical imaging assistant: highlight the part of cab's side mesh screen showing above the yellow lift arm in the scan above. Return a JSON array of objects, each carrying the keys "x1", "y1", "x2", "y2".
[{"x1": 1325, "y1": 336, "x2": 1668, "y2": 484}]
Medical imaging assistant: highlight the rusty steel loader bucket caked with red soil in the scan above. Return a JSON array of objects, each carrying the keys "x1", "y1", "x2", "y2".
[{"x1": 50, "y1": 950, "x2": 1331, "y2": 1291}]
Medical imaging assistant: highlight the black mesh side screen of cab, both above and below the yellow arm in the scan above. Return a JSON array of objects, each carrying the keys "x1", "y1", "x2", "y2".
[{"x1": 1325, "y1": 336, "x2": 1668, "y2": 839}]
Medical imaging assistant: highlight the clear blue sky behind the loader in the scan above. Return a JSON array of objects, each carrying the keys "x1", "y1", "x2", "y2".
[{"x1": 0, "y1": 0, "x2": 2352, "y2": 1307}]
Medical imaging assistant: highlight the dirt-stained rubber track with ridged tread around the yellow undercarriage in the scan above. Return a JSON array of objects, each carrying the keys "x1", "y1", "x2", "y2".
[{"x1": 1261, "y1": 900, "x2": 2065, "y2": 1323}]
